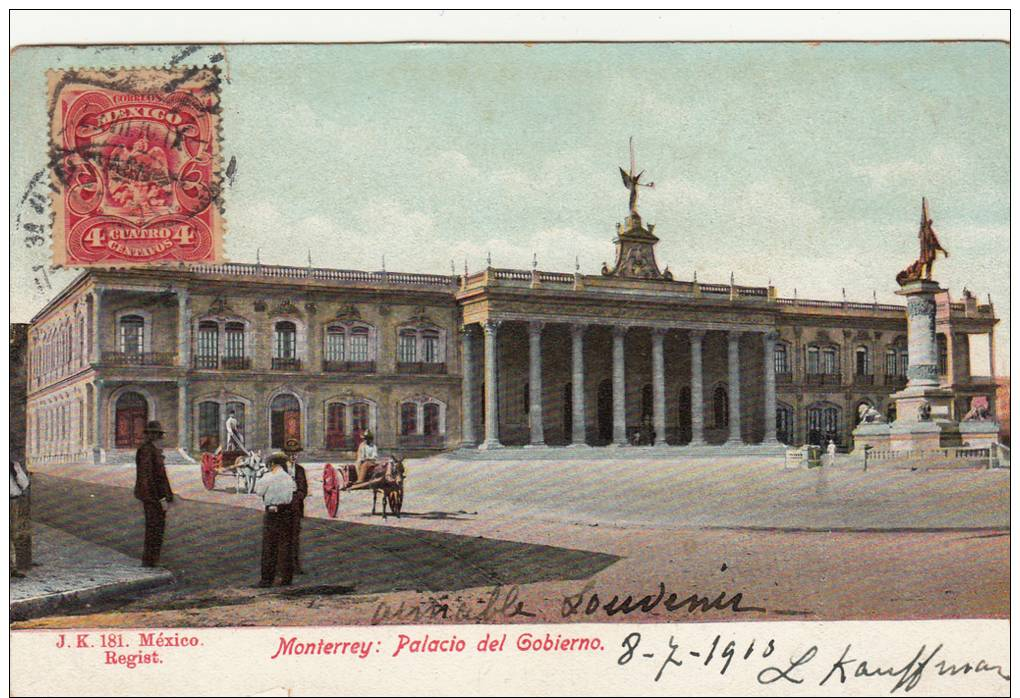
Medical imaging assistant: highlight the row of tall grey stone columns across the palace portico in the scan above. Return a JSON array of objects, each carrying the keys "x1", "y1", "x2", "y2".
[{"x1": 461, "y1": 320, "x2": 779, "y2": 449}]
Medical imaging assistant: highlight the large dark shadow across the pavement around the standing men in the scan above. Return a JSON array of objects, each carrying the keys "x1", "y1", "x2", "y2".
[{"x1": 32, "y1": 473, "x2": 619, "y2": 608}]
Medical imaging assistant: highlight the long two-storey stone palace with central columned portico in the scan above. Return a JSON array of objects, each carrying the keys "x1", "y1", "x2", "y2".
[{"x1": 27, "y1": 202, "x2": 998, "y2": 463}]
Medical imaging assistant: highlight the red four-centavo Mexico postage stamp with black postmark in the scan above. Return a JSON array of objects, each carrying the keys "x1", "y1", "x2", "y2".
[{"x1": 48, "y1": 67, "x2": 223, "y2": 266}]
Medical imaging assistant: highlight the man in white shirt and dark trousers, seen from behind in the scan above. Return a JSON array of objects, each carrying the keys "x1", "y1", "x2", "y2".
[{"x1": 255, "y1": 453, "x2": 297, "y2": 587}]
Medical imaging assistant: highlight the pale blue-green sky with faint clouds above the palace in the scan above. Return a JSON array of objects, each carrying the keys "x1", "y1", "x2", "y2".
[{"x1": 11, "y1": 43, "x2": 1010, "y2": 372}]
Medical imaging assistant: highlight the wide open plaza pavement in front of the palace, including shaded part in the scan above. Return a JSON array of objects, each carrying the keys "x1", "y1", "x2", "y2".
[{"x1": 19, "y1": 456, "x2": 1010, "y2": 627}]
